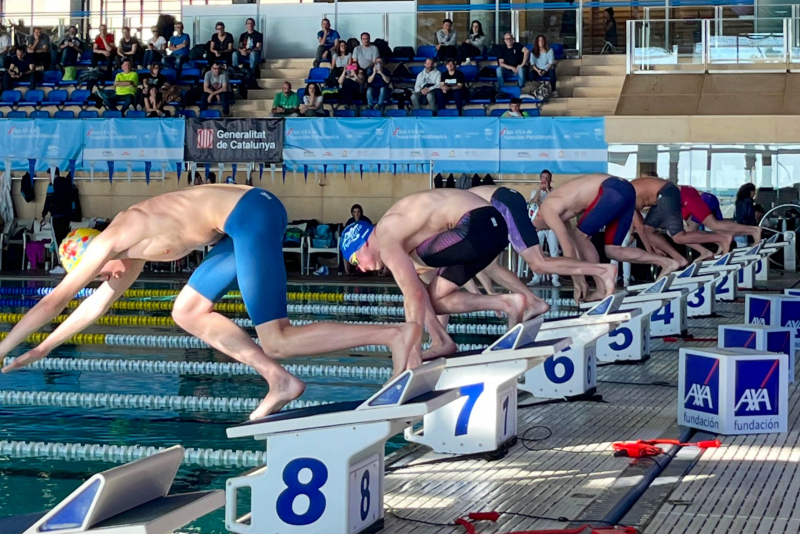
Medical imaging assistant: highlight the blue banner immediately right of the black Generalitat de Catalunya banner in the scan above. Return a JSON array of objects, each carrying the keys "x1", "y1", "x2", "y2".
[{"x1": 283, "y1": 118, "x2": 392, "y2": 171}]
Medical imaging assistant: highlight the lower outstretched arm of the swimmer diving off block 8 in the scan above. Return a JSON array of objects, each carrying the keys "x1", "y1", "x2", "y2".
[{"x1": 3, "y1": 260, "x2": 145, "y2": 373}]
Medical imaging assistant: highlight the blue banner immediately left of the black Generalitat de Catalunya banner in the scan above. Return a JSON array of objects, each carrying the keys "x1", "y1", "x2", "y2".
[{"x1": 81, "y1": 119, "x2": 186, "y2": 171}]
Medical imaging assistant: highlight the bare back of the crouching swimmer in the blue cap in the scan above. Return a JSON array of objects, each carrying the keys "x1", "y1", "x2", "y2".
[{"x1": 375, "y1": 189, "x2": 489, "y2": 253}]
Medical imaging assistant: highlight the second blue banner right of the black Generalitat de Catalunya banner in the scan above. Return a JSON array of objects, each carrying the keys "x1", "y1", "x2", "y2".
[{"x1": 391, "y1": 117, "x2": 500, "y2": 173}]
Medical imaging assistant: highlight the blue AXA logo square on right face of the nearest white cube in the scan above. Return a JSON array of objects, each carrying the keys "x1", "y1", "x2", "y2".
[{"x1": 733, "y1": 358, "x2": 780, "y2": 416}]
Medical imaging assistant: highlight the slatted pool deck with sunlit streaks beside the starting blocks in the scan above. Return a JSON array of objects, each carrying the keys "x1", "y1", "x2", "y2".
[{"x1": 384, "y1": 273, "x2": 800, "y2": 534}]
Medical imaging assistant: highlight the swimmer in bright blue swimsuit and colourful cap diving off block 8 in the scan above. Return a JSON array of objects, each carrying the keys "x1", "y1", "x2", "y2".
[{"x1": 0, "y1": 185, "x2": 422, "y2": 419}]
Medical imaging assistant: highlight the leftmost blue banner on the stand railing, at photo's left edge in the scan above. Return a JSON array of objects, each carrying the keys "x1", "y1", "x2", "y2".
[{"x1": 0, "y1": 119, "x2": 83, "y2": 172}]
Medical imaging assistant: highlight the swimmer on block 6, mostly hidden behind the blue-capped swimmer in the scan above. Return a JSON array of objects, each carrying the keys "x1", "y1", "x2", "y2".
[{"x1": 469, "y1": 185, "x2": 617, "y2": 302}]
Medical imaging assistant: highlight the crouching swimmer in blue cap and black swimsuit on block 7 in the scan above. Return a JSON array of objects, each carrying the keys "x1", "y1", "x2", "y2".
[{"x1": 341, "y1": 189, "x2": 549, "y2": 363}]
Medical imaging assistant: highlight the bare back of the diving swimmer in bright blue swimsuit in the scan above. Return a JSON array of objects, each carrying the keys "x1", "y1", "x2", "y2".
[{"x1": 103, "y1": 184, "x2": 252, "y2": 261}]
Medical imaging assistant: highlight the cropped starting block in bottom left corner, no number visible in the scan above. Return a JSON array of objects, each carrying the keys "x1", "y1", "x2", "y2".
[{"x1": 0, "y1": 445, "x2": 225, "y2": 534}]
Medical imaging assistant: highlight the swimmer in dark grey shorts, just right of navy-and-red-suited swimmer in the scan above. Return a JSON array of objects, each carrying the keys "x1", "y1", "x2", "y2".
[{"x1": 631, "y1": 177, "x2": 731, "y2": 268}]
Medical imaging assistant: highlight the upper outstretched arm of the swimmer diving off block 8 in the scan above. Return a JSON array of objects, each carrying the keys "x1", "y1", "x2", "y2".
[{"x1": 0, "y1": 232, "x2": 122, "y2": 368}]
